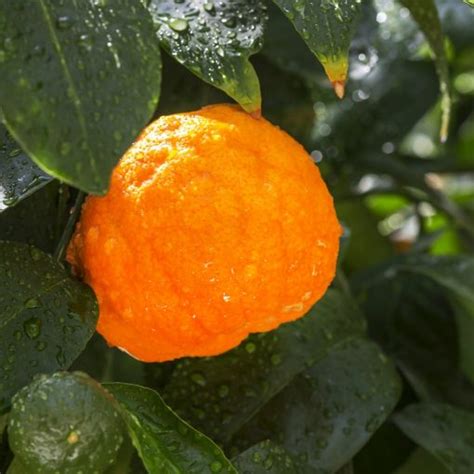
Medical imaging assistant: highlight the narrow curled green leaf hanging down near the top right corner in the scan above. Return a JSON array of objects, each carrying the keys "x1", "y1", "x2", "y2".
[{"x1": 400, "y1": 0, "x2": 452, "y2": 142}]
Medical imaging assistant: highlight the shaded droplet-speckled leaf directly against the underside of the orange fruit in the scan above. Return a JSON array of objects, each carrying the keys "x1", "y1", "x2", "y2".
[{"x1": 163, "y1": 290, "x2": 364, "y2": 441}]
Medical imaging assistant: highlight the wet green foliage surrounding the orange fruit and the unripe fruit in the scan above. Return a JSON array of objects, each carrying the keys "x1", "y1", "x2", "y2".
[{"x1": 0, "y1": 0, "x2": 474, "y2": 474}]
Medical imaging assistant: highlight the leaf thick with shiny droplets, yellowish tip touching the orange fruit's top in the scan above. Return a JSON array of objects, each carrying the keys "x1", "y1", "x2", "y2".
[{"x1": 149, "y1": 0, "x2": 266, "y2": 112}]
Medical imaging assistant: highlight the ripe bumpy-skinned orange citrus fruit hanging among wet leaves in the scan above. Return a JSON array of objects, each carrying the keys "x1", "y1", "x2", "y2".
[{"x1": 68, "y1": 105, "x2": 341, "y2": 361}]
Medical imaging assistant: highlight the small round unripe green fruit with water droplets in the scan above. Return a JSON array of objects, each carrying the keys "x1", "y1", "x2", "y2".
[{"x1": 8, "y1": 372, "x2": 124, "y2": 474}]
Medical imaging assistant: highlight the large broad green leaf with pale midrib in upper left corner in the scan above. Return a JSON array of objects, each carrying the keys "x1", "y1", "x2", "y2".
[{"x1": 0, "y1": 0, "x2": 161, "y2": 193}]
